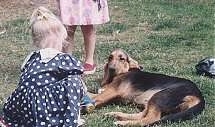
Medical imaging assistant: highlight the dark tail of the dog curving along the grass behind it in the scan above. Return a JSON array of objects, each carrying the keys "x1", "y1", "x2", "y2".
[{"x1": 146, "y1": 97, "x2": 205, "y2": 127}]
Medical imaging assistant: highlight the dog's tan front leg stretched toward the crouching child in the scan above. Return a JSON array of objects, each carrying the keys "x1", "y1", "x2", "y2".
[{"x1": 93, "y1": 87, "x2": 119, "y2": 107}]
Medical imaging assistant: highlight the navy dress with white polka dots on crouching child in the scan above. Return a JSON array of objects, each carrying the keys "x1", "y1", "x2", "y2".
[{"x1": 3, "y1": 49, "x2": 84, "y2": 127}]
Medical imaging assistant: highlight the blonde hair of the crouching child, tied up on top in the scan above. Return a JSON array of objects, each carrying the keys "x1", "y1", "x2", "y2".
[{"x1": 30, "y1": 7, "x2": 67, "y2": 48}]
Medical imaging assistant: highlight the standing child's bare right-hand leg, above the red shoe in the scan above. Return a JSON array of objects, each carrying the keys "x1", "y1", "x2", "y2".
[{"x1": 81, "y1": 25, "x2": 96, "y2": 65}]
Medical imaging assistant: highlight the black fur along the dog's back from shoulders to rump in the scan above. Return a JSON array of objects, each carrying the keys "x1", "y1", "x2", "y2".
[{"x1": 124, "y1": 70, "x2": 200, "y2": 93}]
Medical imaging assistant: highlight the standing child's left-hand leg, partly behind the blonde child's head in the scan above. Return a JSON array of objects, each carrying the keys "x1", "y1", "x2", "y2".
[{"x1": 62, "y1": 26, "x2": 77, "y2": 53}]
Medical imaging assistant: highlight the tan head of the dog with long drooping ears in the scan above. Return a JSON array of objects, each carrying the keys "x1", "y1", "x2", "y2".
[{"x1": 101, "y1": 49, "x2": 142, "y2": 86}]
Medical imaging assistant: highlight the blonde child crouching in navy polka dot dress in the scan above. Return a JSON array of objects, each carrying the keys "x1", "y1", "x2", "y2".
[{"x1": 1, "y1": 7, "x2": 93, "y2": 127}]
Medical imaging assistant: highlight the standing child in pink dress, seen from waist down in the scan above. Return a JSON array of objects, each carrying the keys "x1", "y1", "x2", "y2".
[{"x1": 57, "y1": 0, "x2": 109, "y2": 74}]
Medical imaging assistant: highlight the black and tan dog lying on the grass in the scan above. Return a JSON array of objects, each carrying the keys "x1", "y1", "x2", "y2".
[{"x1": 94, "y1": 49, "x2": 205, "y2": 126}]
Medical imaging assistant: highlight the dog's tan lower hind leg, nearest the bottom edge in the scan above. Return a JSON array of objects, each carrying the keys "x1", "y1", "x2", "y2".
[{"x1": 115, "y1": 105, "x2": 161, "y2": 126}]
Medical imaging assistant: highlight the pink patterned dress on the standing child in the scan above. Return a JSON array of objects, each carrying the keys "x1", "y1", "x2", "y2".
[{"x1": 58, "y1": 0, "x2": 110, "y2": 25}]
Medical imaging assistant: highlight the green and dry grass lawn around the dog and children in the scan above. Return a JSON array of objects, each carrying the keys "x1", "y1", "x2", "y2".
[{"x1": 0, "y1": 0, "x2": 215, "y2": 127}]
